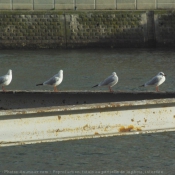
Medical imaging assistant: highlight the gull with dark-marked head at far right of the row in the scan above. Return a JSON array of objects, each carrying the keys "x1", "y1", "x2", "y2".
[{"x1": 140, "y1": 72, "x2": 166, "y2": 92}]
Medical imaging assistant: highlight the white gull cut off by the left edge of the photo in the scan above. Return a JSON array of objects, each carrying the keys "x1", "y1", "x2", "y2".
[{"x1": 0, "y1": 69, "x2": 12, "y2": 92}]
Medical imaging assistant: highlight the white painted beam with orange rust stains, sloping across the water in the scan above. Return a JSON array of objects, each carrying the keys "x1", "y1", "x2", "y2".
[{"x1": 0, "y1": 94, "x2": 175, "y2": 146}]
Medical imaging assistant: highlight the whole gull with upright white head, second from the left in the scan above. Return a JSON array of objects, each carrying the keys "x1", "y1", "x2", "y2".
[{"x1": 36, "y1": 70, "x2": 63, "y2": 92}]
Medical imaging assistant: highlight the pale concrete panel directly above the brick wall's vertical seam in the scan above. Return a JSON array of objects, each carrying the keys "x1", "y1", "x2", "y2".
[{"x1": 55, "y1": 0, "x2": 75, "y2": 10}]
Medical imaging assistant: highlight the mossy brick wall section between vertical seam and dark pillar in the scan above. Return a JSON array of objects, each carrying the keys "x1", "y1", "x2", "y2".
[{"x1": 67, "y1": 12, "x2": 147, "y2": 48}]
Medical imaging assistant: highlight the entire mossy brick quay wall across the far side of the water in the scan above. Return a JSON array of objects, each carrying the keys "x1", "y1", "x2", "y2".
[{"x1": 0, "y1": 10, "x2": 175, "y2": 49}]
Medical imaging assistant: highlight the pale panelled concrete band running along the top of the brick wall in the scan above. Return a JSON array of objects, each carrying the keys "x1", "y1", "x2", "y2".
[{"x1": 0, "y1": 0, "x2": 175, "y2": 10}]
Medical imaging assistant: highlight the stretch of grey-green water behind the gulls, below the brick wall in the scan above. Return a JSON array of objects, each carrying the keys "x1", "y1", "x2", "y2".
[{"x1": 0, "y1": 49, "x2": 175, "y2": 91}]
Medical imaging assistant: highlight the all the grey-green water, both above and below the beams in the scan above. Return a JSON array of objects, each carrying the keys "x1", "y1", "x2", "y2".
[{"x1": 0, "y1": 49, "x2": 175, "y2": 175}]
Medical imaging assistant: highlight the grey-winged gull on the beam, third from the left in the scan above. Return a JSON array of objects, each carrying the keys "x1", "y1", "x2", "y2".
[{"x1": 93, "y1": 72, "x2": 118, "y2": 92}]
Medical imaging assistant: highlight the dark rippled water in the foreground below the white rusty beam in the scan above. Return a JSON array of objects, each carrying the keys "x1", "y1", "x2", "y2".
[{"x1": 0, "y1": 132, "x2": 175, "y2": 175}]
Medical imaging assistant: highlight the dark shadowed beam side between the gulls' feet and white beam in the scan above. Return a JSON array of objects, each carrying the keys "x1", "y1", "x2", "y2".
[{"x1": 0, "y1": 91, "x2": 175, "y2": 110}]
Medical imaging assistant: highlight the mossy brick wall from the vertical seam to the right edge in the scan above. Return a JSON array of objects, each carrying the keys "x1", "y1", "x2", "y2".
[{"x1": 67, "y1": 11, "x2": 175, "y2": 48}]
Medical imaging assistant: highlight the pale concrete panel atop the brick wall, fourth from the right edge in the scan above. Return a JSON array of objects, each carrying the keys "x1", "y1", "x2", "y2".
[{"x1": 95, "y1": 0, "x2": 116, "y2": 10}]
